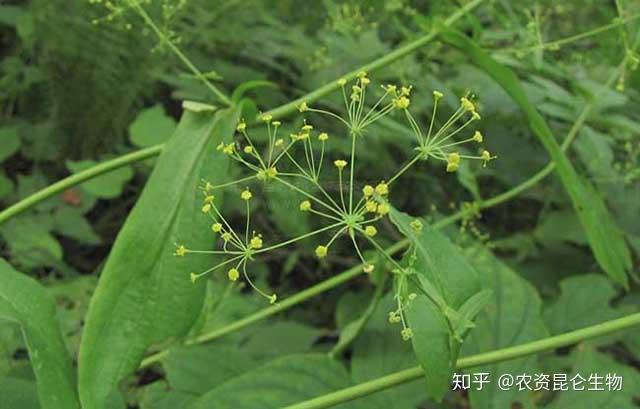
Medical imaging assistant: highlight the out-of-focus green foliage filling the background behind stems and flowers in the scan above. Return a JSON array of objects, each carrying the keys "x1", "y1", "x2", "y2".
[{"x1": 0, "y1": 0, "x2": 640, "y2": 409}]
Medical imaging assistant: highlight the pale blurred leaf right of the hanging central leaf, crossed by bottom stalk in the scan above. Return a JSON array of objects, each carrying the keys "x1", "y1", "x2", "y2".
[{"x1": 463, "y1": 247, "x2": 547, "y2": 409}]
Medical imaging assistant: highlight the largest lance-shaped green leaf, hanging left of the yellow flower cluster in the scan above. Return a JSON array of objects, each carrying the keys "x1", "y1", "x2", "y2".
[{"x1": 79, "y1": 109, "x2": 239, "y2": 409}]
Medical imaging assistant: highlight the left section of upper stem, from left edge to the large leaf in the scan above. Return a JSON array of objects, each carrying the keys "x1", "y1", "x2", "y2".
[{"x1": 0, "y1": 145, "x2": 163, "y2": 224}]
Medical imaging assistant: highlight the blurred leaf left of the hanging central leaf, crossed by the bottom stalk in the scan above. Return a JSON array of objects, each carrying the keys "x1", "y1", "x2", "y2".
[{"x1": 351, "y1": 294, "x2": 427, "y2": 409}]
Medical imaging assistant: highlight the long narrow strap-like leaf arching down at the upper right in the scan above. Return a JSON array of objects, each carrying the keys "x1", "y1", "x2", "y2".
[{"x1": 443, "y1": 31, "x2": 631, "y2": 287}]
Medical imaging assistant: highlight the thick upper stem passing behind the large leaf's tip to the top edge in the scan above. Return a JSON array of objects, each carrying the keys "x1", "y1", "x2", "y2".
[{"x1": 0, "y1": 0, "x2": 483, "y2": 224}]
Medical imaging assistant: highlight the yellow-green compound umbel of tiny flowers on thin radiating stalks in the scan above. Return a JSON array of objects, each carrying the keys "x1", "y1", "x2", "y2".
[{"x1": 175, "y1": 72, "x2": 494, "y2": 340}]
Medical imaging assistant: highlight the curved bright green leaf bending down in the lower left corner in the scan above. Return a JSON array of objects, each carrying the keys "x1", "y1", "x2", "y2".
[{"x1": 0, "y1": 259, "x2": 80, "y2": 409}]
